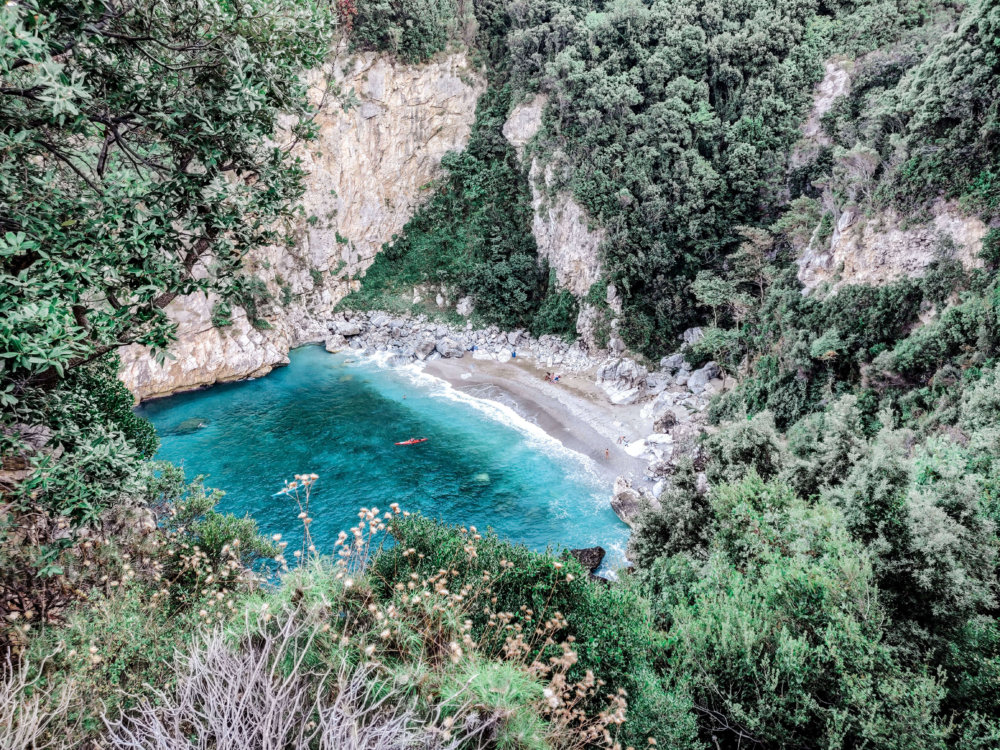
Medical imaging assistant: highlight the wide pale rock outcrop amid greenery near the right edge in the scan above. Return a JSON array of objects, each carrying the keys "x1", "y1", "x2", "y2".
[{"x1": 798, "y1": 200, "x2": 988, "y2": 290}]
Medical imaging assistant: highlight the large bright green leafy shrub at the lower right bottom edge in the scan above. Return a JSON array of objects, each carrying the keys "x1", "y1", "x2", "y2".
[{"x1": 668, "y1": 474, "x2": 946, "y2": 749}]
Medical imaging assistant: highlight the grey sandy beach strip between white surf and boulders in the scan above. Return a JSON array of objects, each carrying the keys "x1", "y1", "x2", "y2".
[{"x1": 425, "y1": 353, "x2": 652, "y2": 484}]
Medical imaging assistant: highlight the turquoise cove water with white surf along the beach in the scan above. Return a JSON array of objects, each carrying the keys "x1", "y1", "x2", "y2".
[{"x1": 138, "y1": 346, "x2": 628, "y2": 567}]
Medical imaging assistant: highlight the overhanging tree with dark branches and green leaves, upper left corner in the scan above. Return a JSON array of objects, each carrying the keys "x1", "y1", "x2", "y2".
[{"x1": 0, "y1": 0, "x2": 329, "y2": 406}]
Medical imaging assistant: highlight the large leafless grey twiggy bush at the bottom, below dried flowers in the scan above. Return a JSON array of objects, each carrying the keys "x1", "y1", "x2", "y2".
[{"x1": 105, "y1": 610, "x2": 491, "y2": 750}]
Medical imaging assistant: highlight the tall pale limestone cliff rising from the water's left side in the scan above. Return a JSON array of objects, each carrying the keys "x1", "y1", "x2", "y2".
[{"x1": 120, "y1": 48, "x2": 485, "y2": 399}]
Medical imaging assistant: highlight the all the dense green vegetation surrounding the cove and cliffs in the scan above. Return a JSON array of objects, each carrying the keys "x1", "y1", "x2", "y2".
[{"x1": 0, "y1": 0, "x2": 1000, "y2": 750}]
